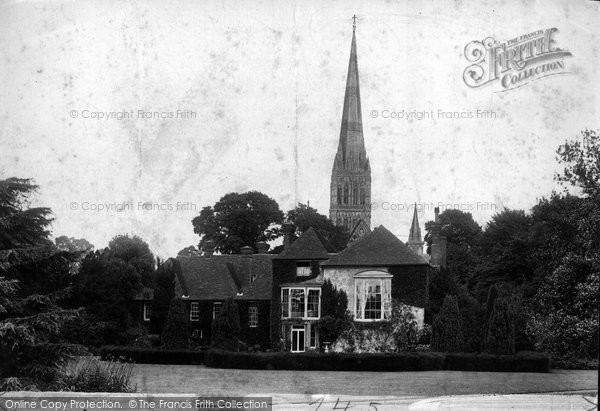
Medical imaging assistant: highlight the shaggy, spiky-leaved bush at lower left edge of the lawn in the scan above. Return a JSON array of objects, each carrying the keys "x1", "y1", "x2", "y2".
[{"x1": 58, "y1": 357, "x2": 137, "y2": 392}]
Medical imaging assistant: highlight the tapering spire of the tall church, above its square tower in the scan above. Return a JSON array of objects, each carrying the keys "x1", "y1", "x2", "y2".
[{"x1": 333, "y1": 25, "x2": 370, "y2": 171}]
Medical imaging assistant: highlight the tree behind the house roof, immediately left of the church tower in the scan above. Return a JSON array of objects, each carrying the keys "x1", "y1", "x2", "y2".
[{"x1": 287, "y1": 203, "x2": 349, "y2": 252}]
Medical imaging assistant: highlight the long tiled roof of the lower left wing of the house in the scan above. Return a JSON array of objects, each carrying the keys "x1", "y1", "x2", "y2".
[{"x1": 176, "y1": 254, "x2": 275, "y2": 300}]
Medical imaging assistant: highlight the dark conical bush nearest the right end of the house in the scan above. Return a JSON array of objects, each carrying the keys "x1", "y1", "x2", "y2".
[{"x1": 431, "y1": 295, "x2": 464, "y2": 352}]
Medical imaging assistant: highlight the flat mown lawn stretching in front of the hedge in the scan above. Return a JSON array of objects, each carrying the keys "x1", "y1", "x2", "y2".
[{"x1": 133, "y1": 364, "x2": 597, "y2": 397}]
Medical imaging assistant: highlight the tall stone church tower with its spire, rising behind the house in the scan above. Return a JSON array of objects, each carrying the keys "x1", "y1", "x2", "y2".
[{"x1": 329, "y1": 24, "x2": 371, "y2": 241}]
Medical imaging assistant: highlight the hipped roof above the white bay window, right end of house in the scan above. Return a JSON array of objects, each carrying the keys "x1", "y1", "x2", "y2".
[{"x1": 322, "y1": 225, "x2": 427, "y2": 266}]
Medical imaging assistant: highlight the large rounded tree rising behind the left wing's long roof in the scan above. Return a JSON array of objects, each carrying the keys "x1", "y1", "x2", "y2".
[{"x1": 192, "y1": 191, "x2": 283, "y2": 254}]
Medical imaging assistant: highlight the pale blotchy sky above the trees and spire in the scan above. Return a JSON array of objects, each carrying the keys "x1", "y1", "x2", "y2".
[{"x1": 0, "y1": 0, "x2": 600, "y2": 258}]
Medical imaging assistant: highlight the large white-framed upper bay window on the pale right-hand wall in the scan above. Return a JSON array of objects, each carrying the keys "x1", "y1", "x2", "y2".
[{"x1": 354, "y1": 271, "x2": 392, "y2": 321}]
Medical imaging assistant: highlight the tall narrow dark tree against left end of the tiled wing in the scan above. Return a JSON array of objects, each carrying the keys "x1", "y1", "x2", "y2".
[{"x1": 149, "y1": 258, "x2": 179, "y2": 334}]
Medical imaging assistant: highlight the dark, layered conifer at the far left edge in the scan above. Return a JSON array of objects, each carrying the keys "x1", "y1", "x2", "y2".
[{"x1": 0, "y1": 178, "x2": 78, "y2": 391}]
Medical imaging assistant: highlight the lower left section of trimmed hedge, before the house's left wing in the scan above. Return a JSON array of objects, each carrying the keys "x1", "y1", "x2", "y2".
[{"x1": 100, "y1": 345, "x2": 205, "y2": 364}]
